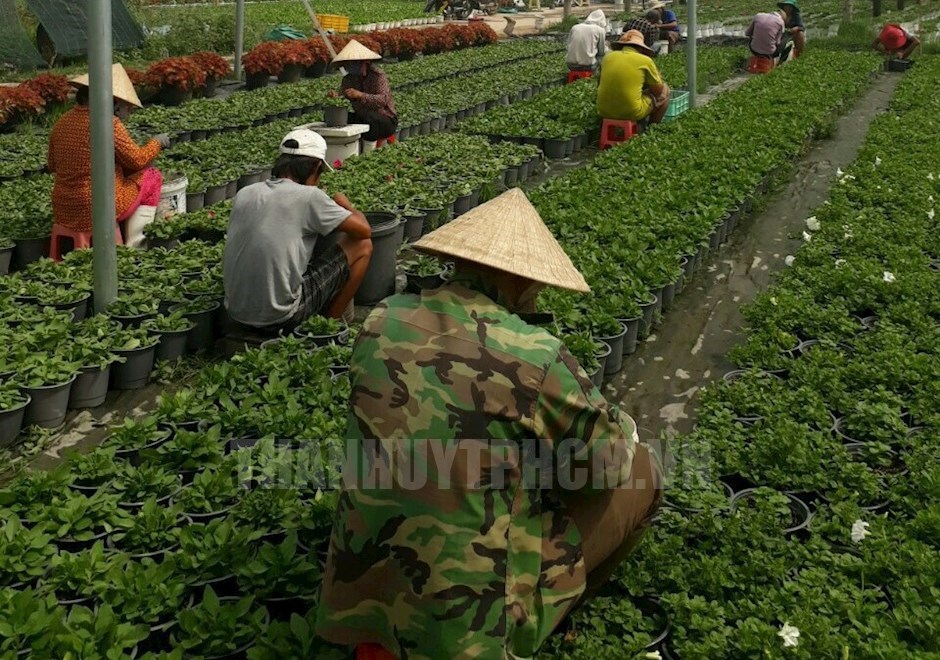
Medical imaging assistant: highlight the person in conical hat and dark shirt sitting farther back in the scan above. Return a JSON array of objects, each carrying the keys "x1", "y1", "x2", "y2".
[{"x1": 332, "y1": 39, "x2": 398, "y2": 151}]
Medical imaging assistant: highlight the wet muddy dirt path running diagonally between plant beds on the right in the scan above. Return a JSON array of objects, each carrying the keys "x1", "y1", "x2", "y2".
[{"x1": 607, "y1": 74, "x2": 900, "y2": 438}]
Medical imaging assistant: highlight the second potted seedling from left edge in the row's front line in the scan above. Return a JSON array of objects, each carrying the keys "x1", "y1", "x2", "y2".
[{"x1": 17, "y1": 353, "x2": 78, "y2": 428}]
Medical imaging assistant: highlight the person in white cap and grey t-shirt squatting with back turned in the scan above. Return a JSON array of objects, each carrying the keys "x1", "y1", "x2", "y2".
[{"x1": 222, "y1": 128, "x2": 372, "y2": 335}]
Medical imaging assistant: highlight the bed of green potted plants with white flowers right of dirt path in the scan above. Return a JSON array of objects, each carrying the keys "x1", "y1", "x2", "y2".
[{"x1": 604, "y1": 60, "x2": 940, "y2": 658}]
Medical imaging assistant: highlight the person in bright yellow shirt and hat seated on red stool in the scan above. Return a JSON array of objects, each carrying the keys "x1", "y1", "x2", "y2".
[{"x1": 597, "y1": 30, "x2": 669, "y2": 124}]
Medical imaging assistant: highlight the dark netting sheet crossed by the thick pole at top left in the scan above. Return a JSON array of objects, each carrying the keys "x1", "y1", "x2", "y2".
[{"x1": 25, "y1": 0, "x2": 144, "y2": 57}]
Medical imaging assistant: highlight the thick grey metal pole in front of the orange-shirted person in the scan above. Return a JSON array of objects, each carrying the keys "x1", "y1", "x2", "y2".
[{"x1": 88, "y1": 0, "x2": 117, "y2": 312}]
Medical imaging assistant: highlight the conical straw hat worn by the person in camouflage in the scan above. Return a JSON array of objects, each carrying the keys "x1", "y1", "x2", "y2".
[{"x1": 414, "y1": 188, "x2": 591, "y2": 293}]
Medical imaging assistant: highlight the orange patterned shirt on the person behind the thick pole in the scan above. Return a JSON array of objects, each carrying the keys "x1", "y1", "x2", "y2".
[{"x1": 48, "y1": 105, "x2": 160, "y2": 231}]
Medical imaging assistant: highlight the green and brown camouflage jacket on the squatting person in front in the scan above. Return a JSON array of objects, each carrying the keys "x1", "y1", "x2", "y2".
[{"x1": 317, "y1": 282, "x2": 636, "y2": 660}]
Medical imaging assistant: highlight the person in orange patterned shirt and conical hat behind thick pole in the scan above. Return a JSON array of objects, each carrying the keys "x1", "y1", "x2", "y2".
[{"x1": 48, "y1": 64, "x2": 170, "y2": 232}]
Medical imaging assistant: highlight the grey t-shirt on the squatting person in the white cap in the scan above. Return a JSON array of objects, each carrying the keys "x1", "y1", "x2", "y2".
[{"x1": 222, "y1": 179, "x2": 351, "y2": 327}]
